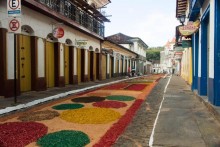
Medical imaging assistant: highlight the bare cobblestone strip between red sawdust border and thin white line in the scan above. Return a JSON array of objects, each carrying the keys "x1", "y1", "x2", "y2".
[{"x1": 114, "y1": 77, "x2": 169, "y2": 147}]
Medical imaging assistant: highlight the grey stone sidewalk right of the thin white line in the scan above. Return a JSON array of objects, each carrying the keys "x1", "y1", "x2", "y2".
[{"x1": 150, "y1": 76, "x2": 220, "y2": 147}]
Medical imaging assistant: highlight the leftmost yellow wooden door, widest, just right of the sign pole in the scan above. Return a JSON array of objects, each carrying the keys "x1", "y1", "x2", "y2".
[{"x1": 19, "y1": 35, "x2": 31, "y2": 92}]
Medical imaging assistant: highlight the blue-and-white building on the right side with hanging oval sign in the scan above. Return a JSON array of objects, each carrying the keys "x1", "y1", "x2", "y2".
[{"x1": 176, "y1": 0, "x2": 220, "y2": 106}]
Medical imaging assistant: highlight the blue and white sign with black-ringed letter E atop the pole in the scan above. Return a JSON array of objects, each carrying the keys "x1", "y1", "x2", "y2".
[{"x1": 7, "y1": 0, "x2": 21, "y2": 17}]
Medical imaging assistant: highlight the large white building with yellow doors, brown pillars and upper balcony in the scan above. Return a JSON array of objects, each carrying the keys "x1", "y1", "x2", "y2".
[{"x1": 0, "y1": 0, "x2": 110, "y2": 97}]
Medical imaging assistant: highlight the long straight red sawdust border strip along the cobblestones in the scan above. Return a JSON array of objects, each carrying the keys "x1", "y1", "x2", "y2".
[{"x1": 94, "y1": 99, "x2": 143, "y2": 147}]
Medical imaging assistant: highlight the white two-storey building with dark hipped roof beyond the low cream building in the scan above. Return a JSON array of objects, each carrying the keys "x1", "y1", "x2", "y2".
[{"x1": 107, "y1": 33, "x2": 148, "y2": 74}]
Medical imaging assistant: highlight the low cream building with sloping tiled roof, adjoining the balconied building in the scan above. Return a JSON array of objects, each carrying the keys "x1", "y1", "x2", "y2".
[{"x1": 101, "y1": 38, "x2": 138, "y2": 79}]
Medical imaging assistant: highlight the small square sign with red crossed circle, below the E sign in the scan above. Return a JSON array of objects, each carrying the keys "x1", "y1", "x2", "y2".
[{"x1": 8, "y1": 18, "x2": 21, "y2": 33}]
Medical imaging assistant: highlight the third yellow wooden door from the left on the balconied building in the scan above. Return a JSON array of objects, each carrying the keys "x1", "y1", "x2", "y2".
[{"x1": 64, "y1": 45, "x2": 70, "y2": 85}]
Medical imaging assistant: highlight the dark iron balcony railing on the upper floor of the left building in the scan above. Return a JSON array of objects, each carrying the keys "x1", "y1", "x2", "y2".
[{"x1": 36, "y1": 0, "x2": 104, "y2": 37}]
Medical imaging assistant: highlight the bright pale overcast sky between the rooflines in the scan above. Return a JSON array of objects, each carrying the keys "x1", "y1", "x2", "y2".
[{"x1": 103, "y1": 0, "x2": 179, "y2": 47}]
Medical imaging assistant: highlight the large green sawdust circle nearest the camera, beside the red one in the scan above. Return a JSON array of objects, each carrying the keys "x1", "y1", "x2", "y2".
[{"x1": 37, "y1": 130, "x2": 90, "y2": 147}]
